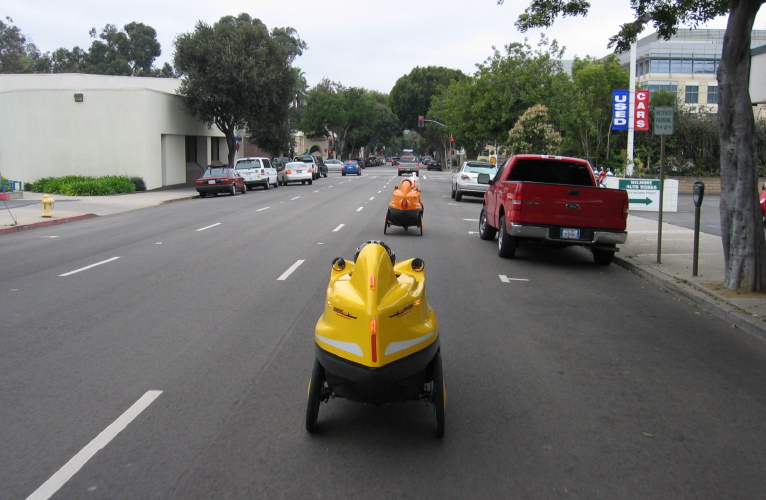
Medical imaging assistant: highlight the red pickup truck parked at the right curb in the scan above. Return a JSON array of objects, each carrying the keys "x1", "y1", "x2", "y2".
[{"x1": 478, "y1": 155, "x2": 628, "y2": 265}]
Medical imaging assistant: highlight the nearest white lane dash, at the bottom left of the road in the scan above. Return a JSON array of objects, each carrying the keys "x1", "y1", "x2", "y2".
[{"x1": 27, "y1": 391, "x2": 162, "y2": 500}]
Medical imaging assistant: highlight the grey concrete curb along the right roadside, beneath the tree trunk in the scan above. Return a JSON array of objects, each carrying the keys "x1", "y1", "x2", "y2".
[{"x1": 614, "y1": 257, "x2": 766, "y2": 342}]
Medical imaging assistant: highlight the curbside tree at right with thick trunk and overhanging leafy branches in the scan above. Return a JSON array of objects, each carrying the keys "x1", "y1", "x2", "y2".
[{"x1": 498, "y1": 0, "x2": 766, "y2": 292}]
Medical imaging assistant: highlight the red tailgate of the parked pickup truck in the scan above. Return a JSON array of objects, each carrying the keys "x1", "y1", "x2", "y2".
[{"x1": 510, "y1": 182, "x2": 627, "y2": 231}]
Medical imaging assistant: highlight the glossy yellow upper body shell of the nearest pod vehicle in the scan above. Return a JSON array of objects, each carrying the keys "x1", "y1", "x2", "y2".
[{"x1": 314, "y1": 244, "x2": 439, "y2": 368}]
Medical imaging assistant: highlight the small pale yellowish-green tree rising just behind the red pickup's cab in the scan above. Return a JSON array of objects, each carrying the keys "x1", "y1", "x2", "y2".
[{"x1": 508, "y1": 104, "x2": 562, "y2": 155}]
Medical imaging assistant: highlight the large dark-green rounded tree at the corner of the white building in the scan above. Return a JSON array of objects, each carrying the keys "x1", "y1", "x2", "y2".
[{"x1": 174, "y1": 13, "x2": 304, "y2": 164}]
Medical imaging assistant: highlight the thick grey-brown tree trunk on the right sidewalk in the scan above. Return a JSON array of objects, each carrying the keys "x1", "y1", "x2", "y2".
[{"x1": 718, "y1": 0, "x2": 766, "y2": 292}]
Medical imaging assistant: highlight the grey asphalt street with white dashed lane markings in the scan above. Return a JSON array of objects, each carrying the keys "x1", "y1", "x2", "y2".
[{"x1": 0, "y1": 167, "x2": 766, "y2": 499}]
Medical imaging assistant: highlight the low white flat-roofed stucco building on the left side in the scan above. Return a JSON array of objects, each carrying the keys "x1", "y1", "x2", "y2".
[{"x1": 0, "y1": 74, "x2": 228, "y2": 189}]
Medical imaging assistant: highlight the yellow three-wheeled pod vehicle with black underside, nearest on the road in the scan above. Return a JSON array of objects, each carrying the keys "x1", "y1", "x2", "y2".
[{"x1": 306, "y1": 240, "x2": 447, "y2": 437}]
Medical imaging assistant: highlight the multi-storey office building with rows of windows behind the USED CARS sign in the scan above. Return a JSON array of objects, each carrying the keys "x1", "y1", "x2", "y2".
[{"x1": 617, "y1": 29, "x2": 766, "y2": 113}]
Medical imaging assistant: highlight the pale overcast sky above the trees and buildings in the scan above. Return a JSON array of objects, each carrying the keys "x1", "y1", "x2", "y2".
[{"x1": 6, "y1": 0, "x2": 766, "y2": 93}]
